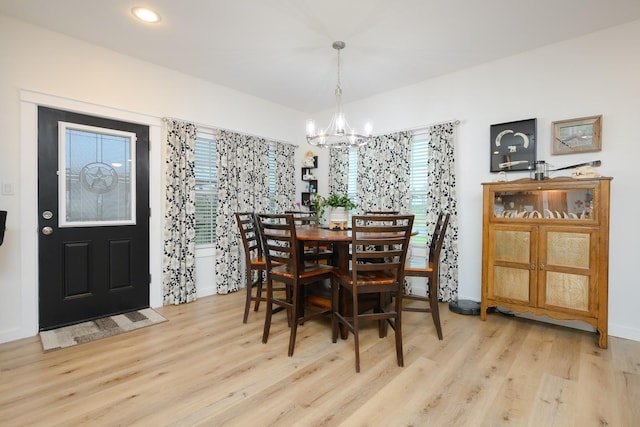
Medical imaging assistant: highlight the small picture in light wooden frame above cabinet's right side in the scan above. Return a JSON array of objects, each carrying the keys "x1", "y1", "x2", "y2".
[{"x1": 551, "y1": 115, "x2": 602, "y2": 154}]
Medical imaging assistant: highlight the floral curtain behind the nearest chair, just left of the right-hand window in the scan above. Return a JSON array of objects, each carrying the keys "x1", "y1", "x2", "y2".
[{"x1": 356, "y1": 132, "x2": 411, "y2": 213}]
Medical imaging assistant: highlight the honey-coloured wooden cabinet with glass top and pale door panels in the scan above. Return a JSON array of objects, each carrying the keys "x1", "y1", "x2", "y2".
[{"x1": 480, "y1": 177, "x2": 611, "y2": 348}]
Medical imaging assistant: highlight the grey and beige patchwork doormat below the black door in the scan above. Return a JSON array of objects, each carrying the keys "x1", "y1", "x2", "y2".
[{"x1": 40, "y1": 308, "x2": 167, "y2": 352}]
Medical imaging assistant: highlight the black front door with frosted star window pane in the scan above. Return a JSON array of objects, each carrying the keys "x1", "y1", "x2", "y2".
[{"x1": 38, "y1": 107, "x2": 149, "y2": 330}]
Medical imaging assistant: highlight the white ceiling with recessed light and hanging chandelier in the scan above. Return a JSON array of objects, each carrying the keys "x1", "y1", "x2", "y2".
[{"x1": 0, "y1": 0, "x2": 640, "y2": 113}]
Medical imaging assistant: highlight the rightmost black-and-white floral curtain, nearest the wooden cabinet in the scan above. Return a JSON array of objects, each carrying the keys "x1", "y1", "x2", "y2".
[{"x1": 427, "y1": 122, "x2": 458, "y2": 301}]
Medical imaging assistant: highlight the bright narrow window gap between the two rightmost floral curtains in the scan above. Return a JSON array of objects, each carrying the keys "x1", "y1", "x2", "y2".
[{"x1": 409, "y1": 133, "x2": 429, "y2": 246}]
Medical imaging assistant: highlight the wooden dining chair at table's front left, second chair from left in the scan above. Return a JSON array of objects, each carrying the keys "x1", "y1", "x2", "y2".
[{"x1": 257, "y1": 214, "x2": 334, "y2": 356}]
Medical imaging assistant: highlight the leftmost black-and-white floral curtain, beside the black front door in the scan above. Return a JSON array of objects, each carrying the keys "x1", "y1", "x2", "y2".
[{"x1": 162, "y1": 119, "x2": 196, "y2": 305}]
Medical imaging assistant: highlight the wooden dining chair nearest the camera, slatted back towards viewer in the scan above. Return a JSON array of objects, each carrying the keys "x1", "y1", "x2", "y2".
[{"x1": 332, "y1": 215, "x2": 414, "y2": 372}]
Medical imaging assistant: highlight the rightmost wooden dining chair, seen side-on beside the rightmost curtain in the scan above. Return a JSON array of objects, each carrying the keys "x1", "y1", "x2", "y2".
[{"x1": 402, "y1": 212, "x2": 451, "y2": 340}]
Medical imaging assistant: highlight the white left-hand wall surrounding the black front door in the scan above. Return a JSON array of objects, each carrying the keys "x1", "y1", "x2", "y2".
[{"x1": 0, "y1": 15, "x2": 306, "y2": 342}]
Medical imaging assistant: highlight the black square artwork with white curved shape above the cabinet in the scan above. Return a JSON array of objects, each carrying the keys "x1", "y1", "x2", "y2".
[{"x1": 491, "y1": 119, "x2": 536, "y2": 172}]
